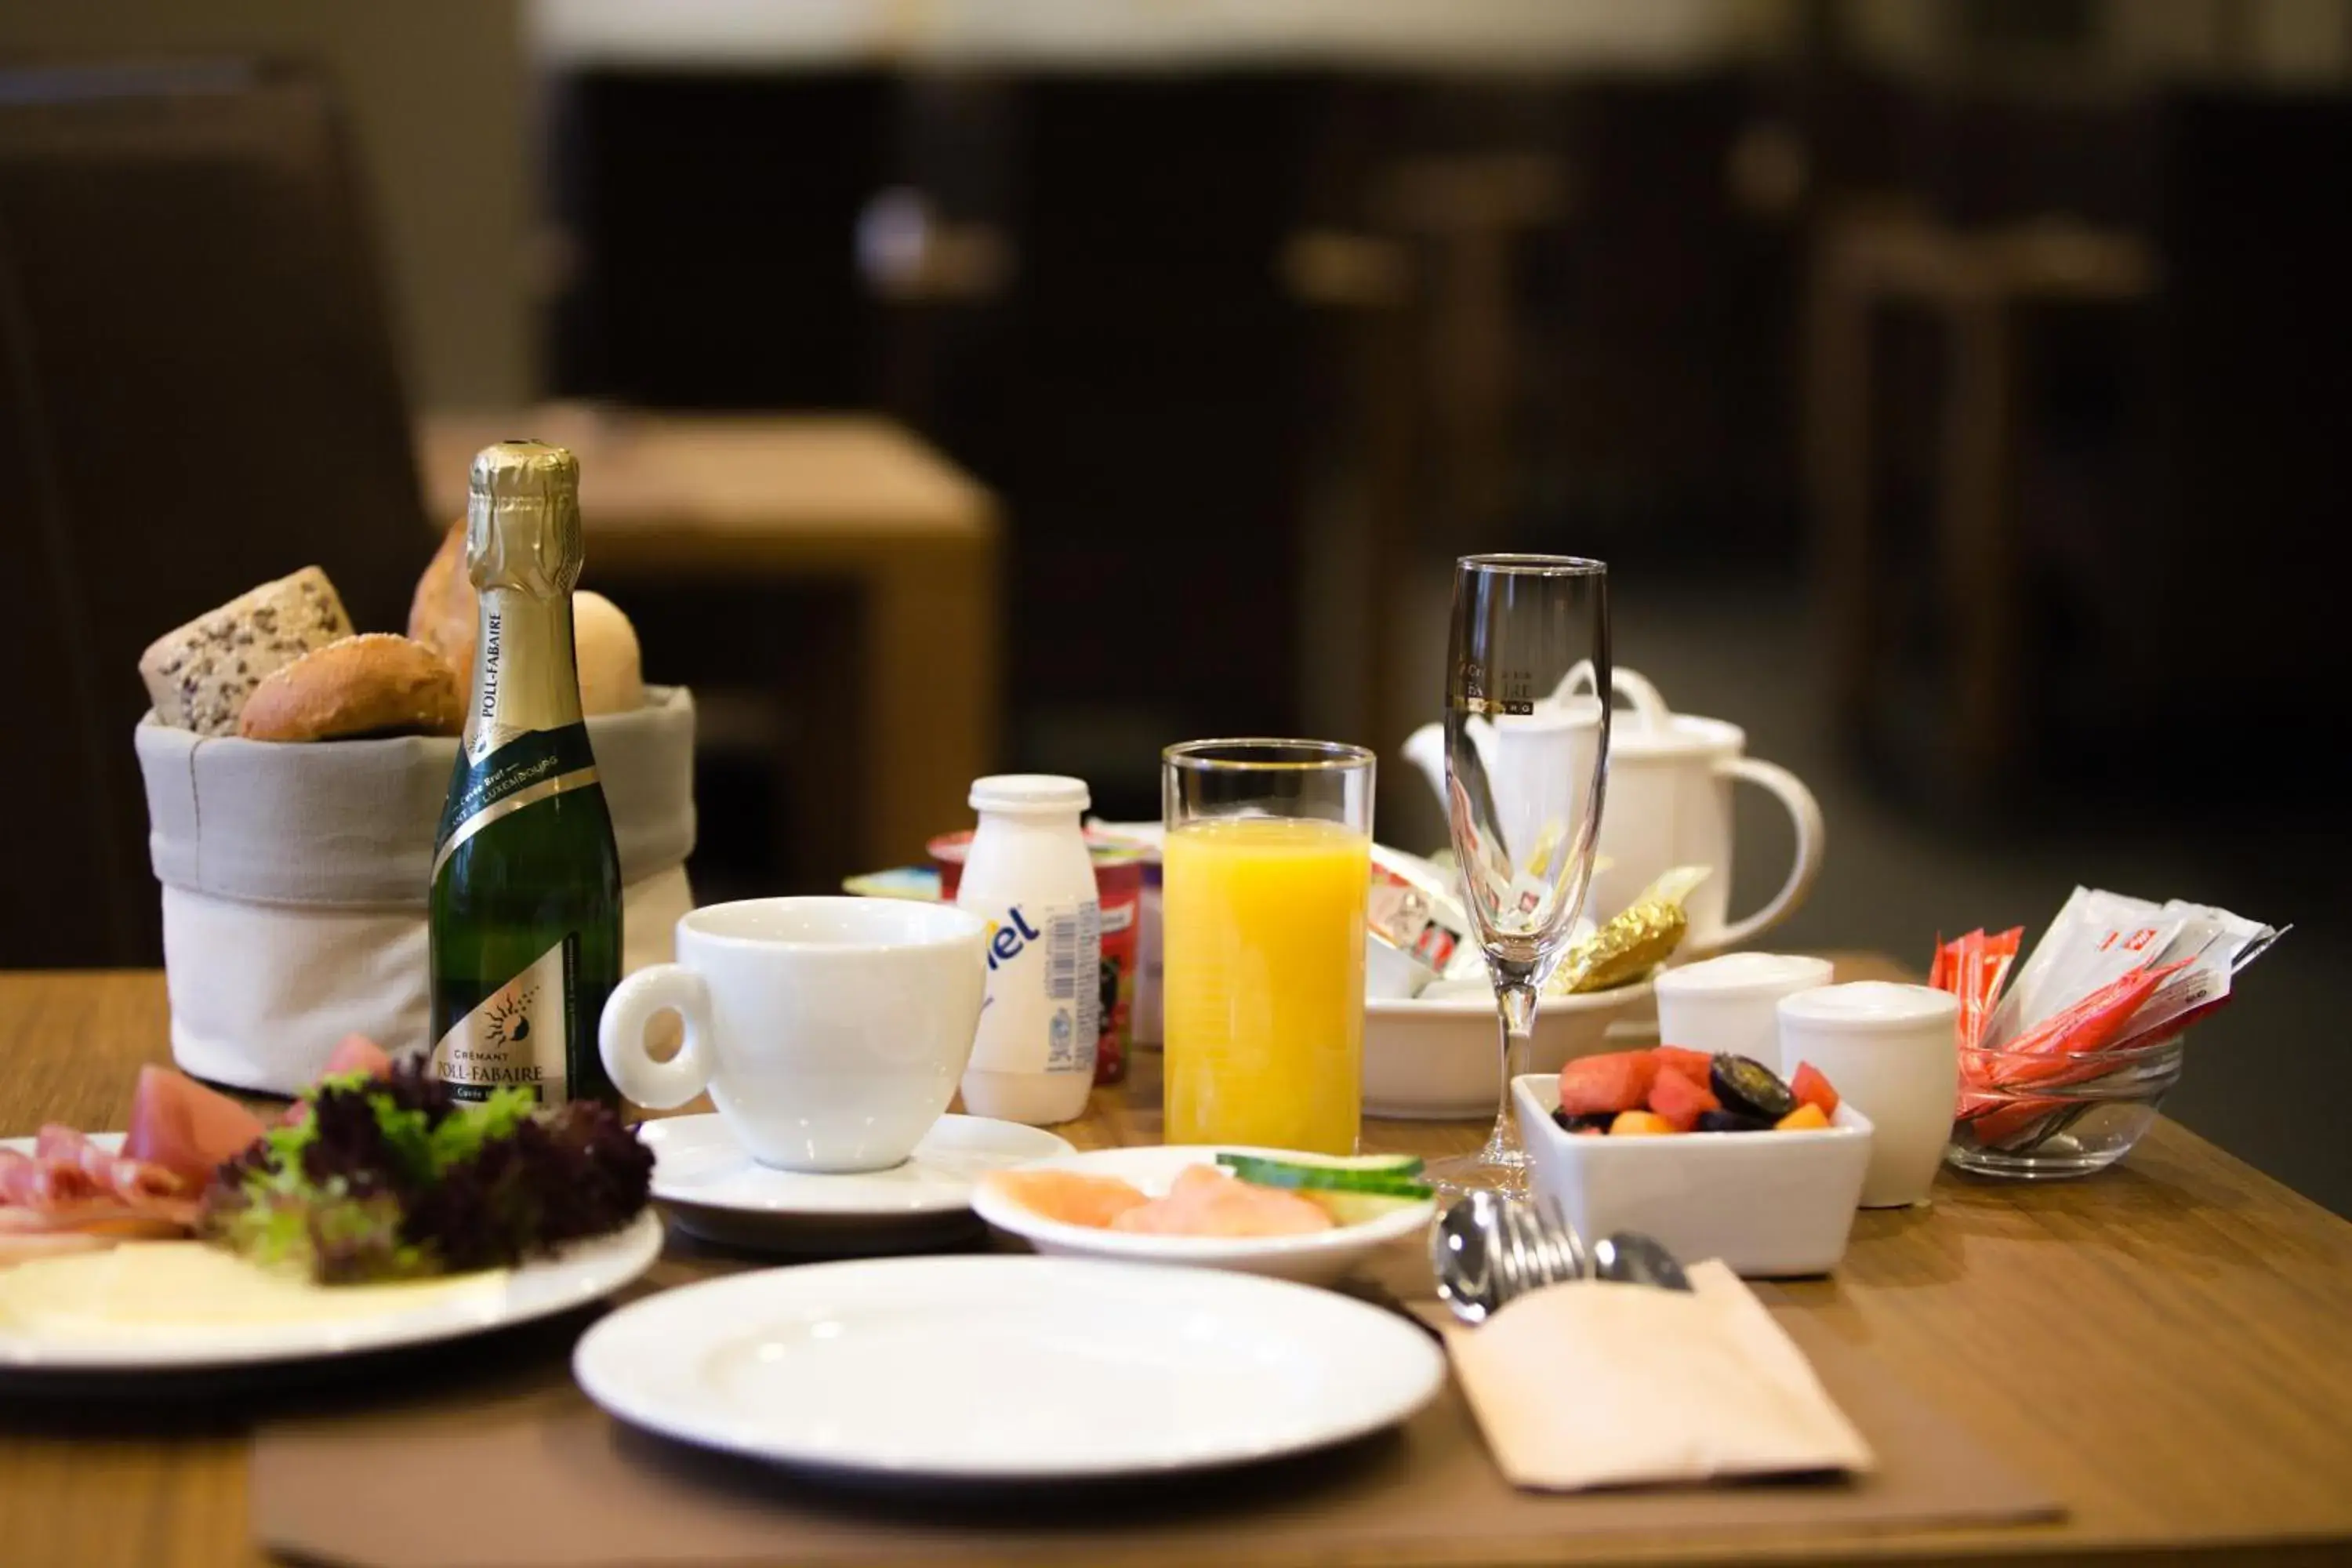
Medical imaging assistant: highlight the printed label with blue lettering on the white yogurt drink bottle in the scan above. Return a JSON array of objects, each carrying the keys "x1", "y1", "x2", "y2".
[{"x1": 971, "y1": 898, "x2": 1103, "y2": 1074}]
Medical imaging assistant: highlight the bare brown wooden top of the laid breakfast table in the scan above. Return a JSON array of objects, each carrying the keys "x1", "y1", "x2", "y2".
[{"x1": 0, "y1": 959, "x2": 2352, "y2": 1568}]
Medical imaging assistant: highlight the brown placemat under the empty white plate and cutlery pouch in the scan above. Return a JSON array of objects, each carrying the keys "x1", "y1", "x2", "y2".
[{"x1": 252, "y1": 1265, "x2": 2063, "y2": 1568}]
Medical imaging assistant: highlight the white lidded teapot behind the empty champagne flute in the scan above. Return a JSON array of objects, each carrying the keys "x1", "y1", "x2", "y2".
[{"x1": 1404, "y1": 666, "x2": 1825, "y2": 956}]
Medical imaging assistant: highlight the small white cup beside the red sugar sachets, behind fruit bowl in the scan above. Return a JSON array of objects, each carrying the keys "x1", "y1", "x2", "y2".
[{"x1": 1780, "y1": 980, "x2": 1959, "y2": 1208}]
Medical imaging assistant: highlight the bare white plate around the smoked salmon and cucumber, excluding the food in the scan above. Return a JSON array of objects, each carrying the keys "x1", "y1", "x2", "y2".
[{"x1": 971, "y1": 1142, "x2": 1437, "y2": 1286}]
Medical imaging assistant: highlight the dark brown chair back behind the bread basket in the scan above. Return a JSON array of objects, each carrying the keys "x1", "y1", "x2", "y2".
[{"x1": 0, "y1": 64, "x2": 430, "y2": 966}]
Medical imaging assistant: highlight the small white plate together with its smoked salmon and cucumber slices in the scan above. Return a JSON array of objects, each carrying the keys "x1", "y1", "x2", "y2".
[{"x1": 971, "y1": 1145, "x2": 1437, "y2": 1283}]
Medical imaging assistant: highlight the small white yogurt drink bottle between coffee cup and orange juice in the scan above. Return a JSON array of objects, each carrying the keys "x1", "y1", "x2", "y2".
[{"x1": 955, "y1": 774, "x2": 1103, "y2": 1126}]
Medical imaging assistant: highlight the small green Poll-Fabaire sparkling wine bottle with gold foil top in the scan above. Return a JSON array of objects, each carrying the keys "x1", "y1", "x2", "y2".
[{"x1": 430, "y1": 442, "x2": 621, "y2": 1105}]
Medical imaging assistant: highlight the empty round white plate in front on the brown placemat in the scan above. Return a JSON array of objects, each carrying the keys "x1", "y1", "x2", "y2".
[{"x1": 572, "y1": 1258, "x2": 1444, "y2": 1483}]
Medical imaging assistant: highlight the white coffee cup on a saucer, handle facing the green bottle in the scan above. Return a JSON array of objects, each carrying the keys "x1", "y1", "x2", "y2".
[{"x1": 597, "y1": 898, "x2": 988, "y2": 1171}]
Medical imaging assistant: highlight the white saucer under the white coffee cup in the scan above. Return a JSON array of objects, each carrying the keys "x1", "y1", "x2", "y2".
[{"x1": 637, "y1": 1114, "x2": 1070, "y2": 1253}]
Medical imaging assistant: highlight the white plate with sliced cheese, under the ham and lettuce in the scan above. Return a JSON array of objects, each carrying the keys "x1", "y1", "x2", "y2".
[{"x1": 0, "y1": 1135, "x2": 661, "y2": 1375}]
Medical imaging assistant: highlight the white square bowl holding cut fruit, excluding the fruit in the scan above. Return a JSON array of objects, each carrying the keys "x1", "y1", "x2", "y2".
[{"x1": 1510, "y1": 1074, "x2": 1870, "y2": 1276}]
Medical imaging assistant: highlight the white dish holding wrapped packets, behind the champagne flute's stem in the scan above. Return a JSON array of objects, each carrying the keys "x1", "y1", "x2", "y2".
[{"x1": 1364, "y1": 980, "x2": 1656, "y2": 1121}]
